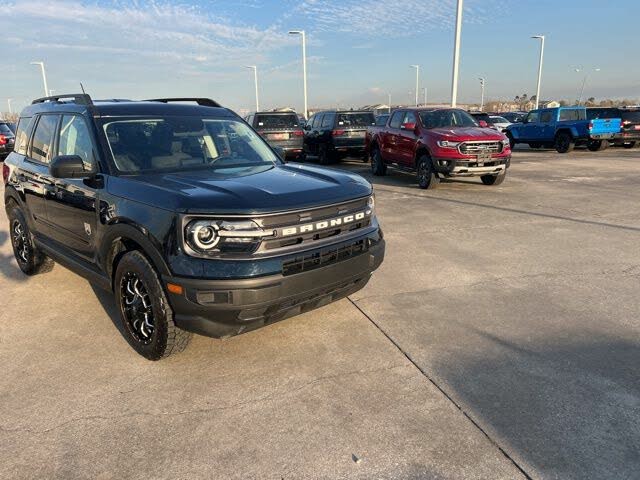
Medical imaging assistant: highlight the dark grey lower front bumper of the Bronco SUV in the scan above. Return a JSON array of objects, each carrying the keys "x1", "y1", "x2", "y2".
[{"x1": 163, "y1": 233, "x2": 385, "y2": 338}]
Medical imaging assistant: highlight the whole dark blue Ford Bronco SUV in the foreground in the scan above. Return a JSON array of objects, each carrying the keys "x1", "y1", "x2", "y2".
[{"x1": 3, "y1": 94, "x2": 384, "y2": 360}]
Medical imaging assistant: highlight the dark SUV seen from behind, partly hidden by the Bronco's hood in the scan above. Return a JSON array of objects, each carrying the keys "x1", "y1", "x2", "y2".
[{"x1": 245, "y1": 112, "x2": 304, "y2": 160}]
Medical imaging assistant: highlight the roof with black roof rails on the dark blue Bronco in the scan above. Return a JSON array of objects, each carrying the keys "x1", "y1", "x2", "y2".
[{"x1": 20, "y1": 94, "x2": 237, "y2": 117}]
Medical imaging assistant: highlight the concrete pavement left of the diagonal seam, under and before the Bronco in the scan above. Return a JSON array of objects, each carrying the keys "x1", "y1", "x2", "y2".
[{"x1": 0, "y1": 183, "x2": 521, "y2": 480}]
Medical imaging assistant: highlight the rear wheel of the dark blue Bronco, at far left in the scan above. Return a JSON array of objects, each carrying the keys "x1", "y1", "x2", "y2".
[{"x1": 9, "y1": 203, "x2": 54, "y2": 275}]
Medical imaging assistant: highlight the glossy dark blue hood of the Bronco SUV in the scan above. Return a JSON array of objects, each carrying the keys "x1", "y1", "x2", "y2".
[{"x1": 109, "y1": 163, "x2": 372, "y2": 214}]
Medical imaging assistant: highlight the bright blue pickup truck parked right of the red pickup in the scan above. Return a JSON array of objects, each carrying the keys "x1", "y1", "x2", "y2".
[{"x1": 506, "y1": 107, "x2": 621, "y2": 153}]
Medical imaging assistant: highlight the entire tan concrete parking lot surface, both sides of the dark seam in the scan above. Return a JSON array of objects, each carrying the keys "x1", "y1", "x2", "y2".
[{"x1": 0, "y1": 149, "x2": 640, "y2": 479}]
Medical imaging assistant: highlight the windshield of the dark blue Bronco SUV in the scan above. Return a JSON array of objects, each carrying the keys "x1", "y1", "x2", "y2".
[{"x1": 103, "y1": 117, "x2": 279, "y2": 173}]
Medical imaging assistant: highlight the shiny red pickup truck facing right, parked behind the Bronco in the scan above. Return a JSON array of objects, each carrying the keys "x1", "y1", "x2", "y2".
[{"x1": 366, "y1": 108, "x2": 511, "y2": 188}]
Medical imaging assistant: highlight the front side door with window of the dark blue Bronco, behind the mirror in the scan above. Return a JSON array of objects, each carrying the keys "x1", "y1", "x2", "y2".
[{"x1": 46, "y1": 114, "x2": 97, "y2": 261}]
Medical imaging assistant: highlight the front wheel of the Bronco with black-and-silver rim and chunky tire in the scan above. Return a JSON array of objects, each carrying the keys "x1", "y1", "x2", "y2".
[{"x1": 113, "y1": 251, "x2": 191, "y2": 360}]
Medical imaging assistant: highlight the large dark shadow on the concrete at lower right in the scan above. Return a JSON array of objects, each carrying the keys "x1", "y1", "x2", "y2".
[{"x1": 434, "y1": 332, "x2": 640, "y2": 479}]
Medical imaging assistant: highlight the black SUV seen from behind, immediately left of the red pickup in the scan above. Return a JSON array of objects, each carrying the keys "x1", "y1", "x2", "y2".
[{"x1": 304, "y1": 110, "x2": 376, "y2": 165}]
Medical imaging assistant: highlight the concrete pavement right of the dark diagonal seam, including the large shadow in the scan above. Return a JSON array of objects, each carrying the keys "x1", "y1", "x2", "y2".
[{"x1": 341, "y1": 148, "x2": 640, "y2": 479}]
